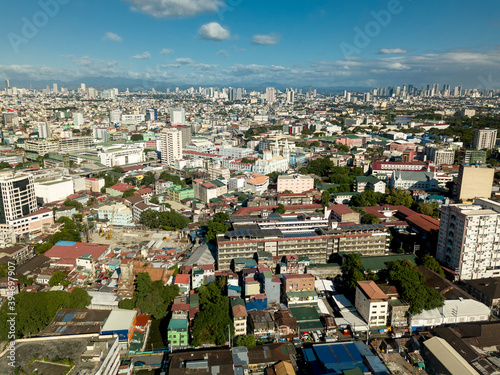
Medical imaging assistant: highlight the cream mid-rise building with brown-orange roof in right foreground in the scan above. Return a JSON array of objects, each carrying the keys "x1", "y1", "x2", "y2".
[{"x1": 354, "y1": 280, "x2": 389, "y2": 327}]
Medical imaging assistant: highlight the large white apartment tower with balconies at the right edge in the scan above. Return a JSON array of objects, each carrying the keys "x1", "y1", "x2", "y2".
[{"x1": 436, "y1": 198, "x2": 500, "y2": 280}]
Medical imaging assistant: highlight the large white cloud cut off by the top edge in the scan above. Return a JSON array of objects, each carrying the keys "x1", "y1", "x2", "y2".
[{"x1": 123, "y1": 0, "x2": 225, "y2": 18}]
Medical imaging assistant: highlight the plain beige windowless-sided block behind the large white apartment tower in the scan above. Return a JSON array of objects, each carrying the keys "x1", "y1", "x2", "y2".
[{"x1": 455, "y1": 164, "x2": 495, "y2": 201}]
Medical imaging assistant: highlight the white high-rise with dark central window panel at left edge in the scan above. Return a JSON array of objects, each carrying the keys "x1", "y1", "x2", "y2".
[{"x1": 0, "y1": 171, "x2": 37, "y2": 224}]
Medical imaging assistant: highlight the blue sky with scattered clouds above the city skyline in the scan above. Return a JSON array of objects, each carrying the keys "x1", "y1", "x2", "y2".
[{"x1": 0, "y1": 0, "x2": 500, "y2": 89}]
